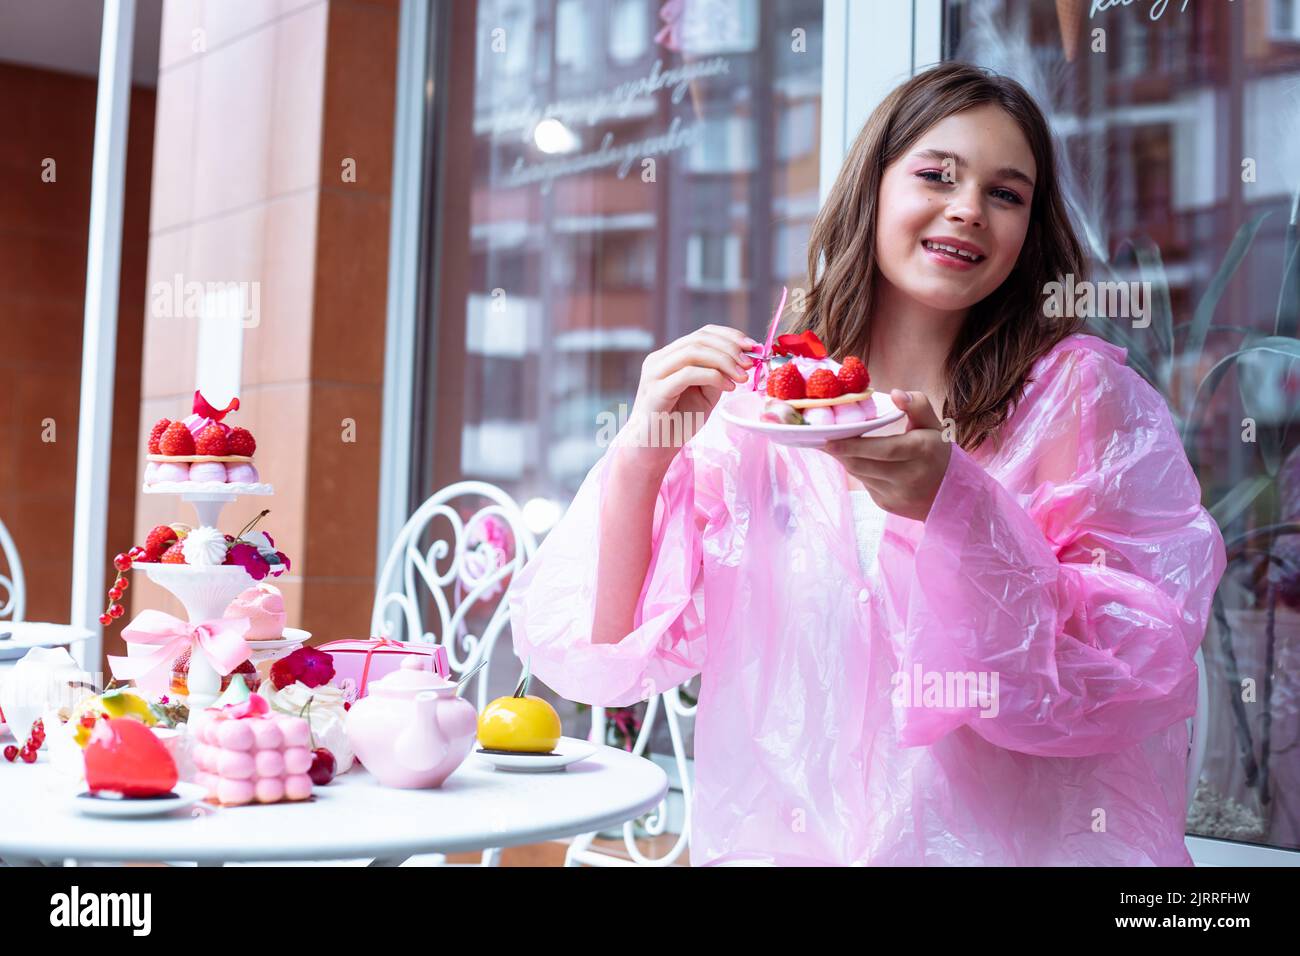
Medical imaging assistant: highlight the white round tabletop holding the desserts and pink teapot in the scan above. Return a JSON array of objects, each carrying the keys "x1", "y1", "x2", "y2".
[{"x1": 0, "y1": 747, "x2": 668, "y2": 865}]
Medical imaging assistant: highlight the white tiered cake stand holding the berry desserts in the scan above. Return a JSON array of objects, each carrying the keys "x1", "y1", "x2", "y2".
[{"x1": 135, "y1": 481, "x2": 274, "y2": 708}]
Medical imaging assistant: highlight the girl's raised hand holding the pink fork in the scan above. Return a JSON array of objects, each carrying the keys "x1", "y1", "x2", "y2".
[{"x1": 618, "y1": 325, "x2": 762, "y2": 458}]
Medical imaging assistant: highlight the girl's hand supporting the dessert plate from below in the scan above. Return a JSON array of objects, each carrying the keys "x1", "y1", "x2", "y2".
[{"x1": 823, "y1": 389, "x2": 953, "y2": 522}]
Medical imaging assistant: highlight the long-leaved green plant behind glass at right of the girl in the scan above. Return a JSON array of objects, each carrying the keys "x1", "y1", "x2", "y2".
[{"x1": 1088, "y1": 206, "x2": 1300, "y2": 845}]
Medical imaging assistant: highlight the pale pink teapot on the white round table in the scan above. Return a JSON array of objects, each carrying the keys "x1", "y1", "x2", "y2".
[{"x1": 343, "y1": 656, "x2": 478, "y2": 790}]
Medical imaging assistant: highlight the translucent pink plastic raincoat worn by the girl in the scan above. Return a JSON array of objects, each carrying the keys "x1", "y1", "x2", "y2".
[{"x1": 510, "y1": 334, "x2": 1226, "y2": 865}]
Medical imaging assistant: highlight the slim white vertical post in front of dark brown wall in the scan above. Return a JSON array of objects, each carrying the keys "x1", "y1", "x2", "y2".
[{"x1": 72, "y1": 0, "x2": 135, "y2": 671}]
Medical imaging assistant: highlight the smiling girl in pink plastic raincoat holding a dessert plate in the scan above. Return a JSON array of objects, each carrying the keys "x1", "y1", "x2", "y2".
[{"x1": 510, "y1": 64, "x2": 1225, "y2": 865}]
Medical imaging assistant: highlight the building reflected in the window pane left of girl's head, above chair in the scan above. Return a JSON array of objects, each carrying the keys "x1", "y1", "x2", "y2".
[{"x1": 439, "y1": 0, "x2": 824, "y2": 501}]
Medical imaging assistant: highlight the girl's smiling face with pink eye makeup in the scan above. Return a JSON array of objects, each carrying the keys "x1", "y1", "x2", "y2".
[{"x1": 876, "y1": 104, "x2": 1037, "y2": 312}]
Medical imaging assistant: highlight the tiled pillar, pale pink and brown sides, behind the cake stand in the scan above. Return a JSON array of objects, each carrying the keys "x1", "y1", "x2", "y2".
[{"x1": 133, "y1": 0, "x2": 398, "y2": 650}]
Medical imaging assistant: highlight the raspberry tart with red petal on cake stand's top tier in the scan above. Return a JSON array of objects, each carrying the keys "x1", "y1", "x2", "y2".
[{"x1": 144, "y1": 392, "x2": 259, "y2": 485}]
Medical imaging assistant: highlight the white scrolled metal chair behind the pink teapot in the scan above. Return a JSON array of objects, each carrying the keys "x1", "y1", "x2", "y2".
[{"x1": 371, "y1": 481, "x2": 537, "y2": 865}]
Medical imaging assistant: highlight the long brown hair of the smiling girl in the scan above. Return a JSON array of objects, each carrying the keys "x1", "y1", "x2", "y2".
[{"x1": 794, "y1": 62, "x2": 1087, "y2": 451}]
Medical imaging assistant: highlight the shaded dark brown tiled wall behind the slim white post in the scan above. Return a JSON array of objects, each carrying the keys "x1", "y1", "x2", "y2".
[{"x1": 0, "y1": 64, "x2": 155, "y2": 634}]
